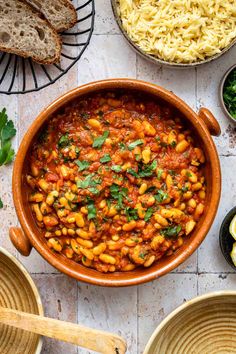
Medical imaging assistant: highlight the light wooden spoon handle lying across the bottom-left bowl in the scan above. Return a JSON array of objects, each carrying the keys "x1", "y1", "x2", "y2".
[{"x1": 0, "y1": 306, "x2": 126, "y2": 354}]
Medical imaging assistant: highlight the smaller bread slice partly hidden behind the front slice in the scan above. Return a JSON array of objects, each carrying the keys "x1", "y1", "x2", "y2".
[{"x1": 26, "y1": 0, "x2": 77, "y2": 32}]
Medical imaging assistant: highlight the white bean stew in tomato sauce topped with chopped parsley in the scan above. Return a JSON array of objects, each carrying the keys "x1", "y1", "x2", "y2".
[{"x1": 26, "y1": 91, "x2": 206, "y2": 272}]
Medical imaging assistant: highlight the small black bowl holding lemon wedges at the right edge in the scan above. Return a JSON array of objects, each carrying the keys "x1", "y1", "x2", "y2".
[{"x1": 220, "y1": 207, "x2": 236, "y2": 270}]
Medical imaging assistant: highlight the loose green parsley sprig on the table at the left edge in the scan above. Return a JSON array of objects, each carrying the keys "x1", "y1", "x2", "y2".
[{"x1": 0, "y1": 108, "x2": 16, "y2": 166}]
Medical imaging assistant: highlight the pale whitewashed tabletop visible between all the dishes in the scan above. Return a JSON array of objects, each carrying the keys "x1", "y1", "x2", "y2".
[{"x1": 0, "y1": 0, "x2": 236, "y2": 354}]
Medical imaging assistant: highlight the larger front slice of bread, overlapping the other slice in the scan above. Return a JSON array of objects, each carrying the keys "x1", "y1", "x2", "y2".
[{"x1": 0, "y1": 0, "x2": 61, "y2": 64}]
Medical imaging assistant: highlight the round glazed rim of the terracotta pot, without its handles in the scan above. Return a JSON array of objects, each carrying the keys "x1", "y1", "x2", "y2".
[{"x1": 12, "y1": 78, "x2": 221, "y2": 286}]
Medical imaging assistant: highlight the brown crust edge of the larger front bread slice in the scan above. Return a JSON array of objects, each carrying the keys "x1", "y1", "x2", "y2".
[{"x1": 0, "y1": 0, "x2": 62, "y2": 65}]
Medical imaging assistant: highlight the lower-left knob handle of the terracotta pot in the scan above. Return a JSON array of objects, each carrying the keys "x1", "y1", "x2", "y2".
[{"x1": 9, "y1": 227, "x2": 32, "y2": 257}]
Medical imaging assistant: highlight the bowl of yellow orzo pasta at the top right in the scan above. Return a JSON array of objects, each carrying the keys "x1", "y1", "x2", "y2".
[{"x1": 111, "y1": 0, "x2": 236, "y2": 68}]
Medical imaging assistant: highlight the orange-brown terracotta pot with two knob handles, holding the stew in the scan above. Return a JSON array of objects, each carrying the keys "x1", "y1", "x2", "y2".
[{"x1": 10, "y1": 79, "x2": 221, "y2": 286}]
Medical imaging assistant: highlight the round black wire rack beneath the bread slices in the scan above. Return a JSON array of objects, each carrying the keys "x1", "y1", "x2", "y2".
[{"x1": 0, "y1": 0, "x2": 95, "y2": 95}]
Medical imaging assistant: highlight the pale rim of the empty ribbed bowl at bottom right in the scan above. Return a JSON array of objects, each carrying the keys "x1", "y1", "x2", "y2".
[{"x1": 143, "y1": 290, "x2": 236, "y2": 354}]
